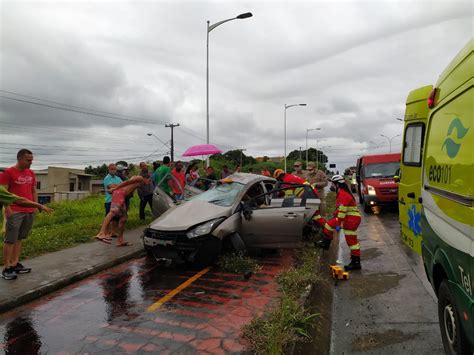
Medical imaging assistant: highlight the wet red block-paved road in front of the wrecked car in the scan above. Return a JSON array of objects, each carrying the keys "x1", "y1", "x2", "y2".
[{"x1": 0, "y1": 251, "x2": 293, "y2": 354}]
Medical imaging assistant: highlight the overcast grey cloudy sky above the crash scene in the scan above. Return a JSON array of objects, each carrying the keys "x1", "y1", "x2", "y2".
[{"x1": 0, "y1": 0, "x2": 473, "y2": 170}]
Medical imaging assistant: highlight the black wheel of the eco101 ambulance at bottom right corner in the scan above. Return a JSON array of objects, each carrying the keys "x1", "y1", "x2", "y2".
[{"x1": 438, "y1": 279, "x2": 472, "y2": 355}]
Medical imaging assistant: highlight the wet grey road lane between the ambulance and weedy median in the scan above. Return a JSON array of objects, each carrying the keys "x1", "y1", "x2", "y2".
[{"x1": 331, "y1": 209, "x2": 444, "y2": 354}]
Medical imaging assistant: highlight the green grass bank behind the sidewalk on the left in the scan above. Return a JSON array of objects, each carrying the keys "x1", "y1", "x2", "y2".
[{"x1": 0, "y1": 195, "x2": 152, "y2": 263}]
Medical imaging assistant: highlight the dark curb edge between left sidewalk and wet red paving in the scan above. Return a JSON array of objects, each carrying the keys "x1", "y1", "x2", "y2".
[{"x1": 0, "y1": 249, "x2": 144, "y2": 314}]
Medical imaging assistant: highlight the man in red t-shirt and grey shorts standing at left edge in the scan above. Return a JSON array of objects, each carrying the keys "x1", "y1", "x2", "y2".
[{"x1": 0, "y1": 149, "x2": 38, "y2": 280}]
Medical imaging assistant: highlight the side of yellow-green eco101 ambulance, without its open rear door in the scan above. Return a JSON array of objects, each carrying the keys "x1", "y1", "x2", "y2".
[{"x1": 418, "y1": 39, "x2": 474, "y2": 354}]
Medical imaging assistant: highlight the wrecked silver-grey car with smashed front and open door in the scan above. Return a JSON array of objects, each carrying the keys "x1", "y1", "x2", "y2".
[{"x1": 143, "y1": 173, "x2": 320, "y2": 265}]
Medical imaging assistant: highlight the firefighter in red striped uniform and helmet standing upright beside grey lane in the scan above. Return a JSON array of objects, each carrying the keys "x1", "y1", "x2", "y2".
[{"x1": 313, "y1": 175, "x2": 361, "y2": 270}]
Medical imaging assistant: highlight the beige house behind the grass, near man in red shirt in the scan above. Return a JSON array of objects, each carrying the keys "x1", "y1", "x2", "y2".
[{"x1": 35, "y1": 166, "x2": 93, "y2": 203}]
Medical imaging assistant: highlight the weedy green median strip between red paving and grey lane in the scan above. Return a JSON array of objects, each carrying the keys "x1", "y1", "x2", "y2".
[{"x1": 243, "y1": 245, "x2": 319, "y2": 354}]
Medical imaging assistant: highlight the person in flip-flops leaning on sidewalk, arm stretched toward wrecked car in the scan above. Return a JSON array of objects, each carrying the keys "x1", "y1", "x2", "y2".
[{"x1": 95, "y1": 176, "x2": 149, "y2": 247}]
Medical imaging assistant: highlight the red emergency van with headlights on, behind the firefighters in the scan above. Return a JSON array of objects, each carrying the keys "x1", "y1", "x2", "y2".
[{"x1": 356, "y1": 153, "x2": 400, "y2": 213}]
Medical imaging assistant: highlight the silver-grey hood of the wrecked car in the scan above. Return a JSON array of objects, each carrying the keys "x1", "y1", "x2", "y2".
[{"x1": 150, "y1": 200, "x2": 232, "y2": 231}]
